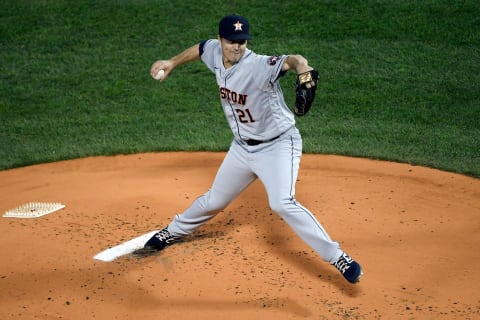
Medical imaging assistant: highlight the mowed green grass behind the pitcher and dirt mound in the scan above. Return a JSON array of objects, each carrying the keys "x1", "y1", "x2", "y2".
[{"x1": 0, "y1": 0, "x2": 480, "y2": 177}]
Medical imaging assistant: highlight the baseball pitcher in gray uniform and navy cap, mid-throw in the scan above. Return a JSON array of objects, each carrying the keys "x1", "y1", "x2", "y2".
[{"x1": 135, "y1": 15, "x2": 362, "y2": 283}]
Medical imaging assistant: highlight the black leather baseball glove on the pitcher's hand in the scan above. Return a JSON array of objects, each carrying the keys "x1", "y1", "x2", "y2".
[{"x1": 294, "y1": 69, "x2": 318, "y2": 116}]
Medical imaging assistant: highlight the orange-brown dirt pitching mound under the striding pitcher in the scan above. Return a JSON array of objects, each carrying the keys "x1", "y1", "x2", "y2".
[{"x1": 0, "y1": 153, "x2": 480, "y2": 320}]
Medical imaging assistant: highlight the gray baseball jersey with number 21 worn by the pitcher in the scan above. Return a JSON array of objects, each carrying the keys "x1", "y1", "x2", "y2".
[{"x1": 201, "y1": 39, "x2": 295, "y2": 140}]
